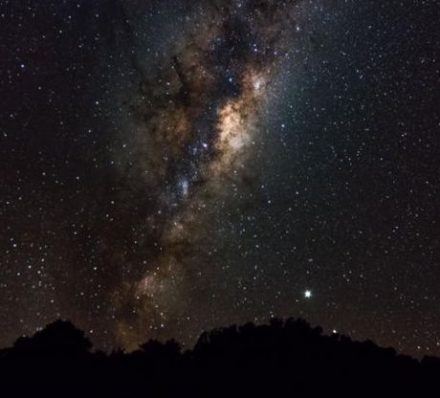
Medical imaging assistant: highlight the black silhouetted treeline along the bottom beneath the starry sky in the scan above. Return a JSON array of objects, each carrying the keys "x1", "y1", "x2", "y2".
[{"x1": 0, "y1": 319, "x2": 440, "y2": 397}]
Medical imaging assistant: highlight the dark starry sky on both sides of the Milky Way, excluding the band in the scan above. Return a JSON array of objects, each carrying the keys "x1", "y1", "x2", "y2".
[{"x1": 0, "y1": 0, "x2": 440, "y2": 355}]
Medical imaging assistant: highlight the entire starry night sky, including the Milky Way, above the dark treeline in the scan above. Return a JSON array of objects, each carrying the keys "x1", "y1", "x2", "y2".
[{"x1": 0, "y1": 0, "x2": 440, "y2": 355}]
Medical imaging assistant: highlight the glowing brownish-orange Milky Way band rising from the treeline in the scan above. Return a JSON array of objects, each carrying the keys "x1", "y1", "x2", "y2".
[{"x1": 111, "y1": 1, "x2": 296, "y2": 344}]
